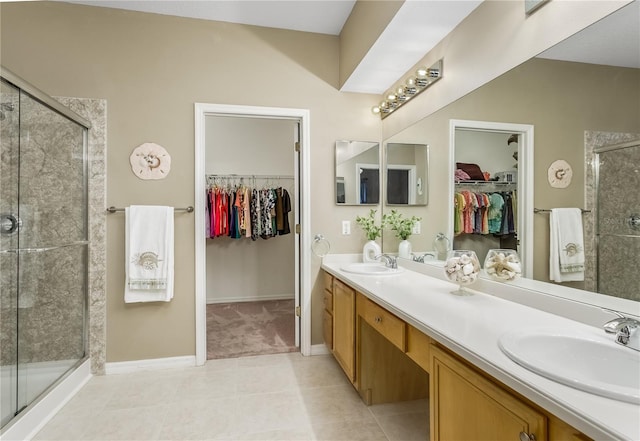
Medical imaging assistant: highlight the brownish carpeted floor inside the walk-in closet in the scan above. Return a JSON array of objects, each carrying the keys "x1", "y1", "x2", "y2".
[{"x1": 207, "y1": 299, "x2": 298, "y2": 360}]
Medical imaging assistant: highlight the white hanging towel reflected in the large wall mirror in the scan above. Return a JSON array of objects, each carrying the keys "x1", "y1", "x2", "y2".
[{"x1": 549, "y1": 208, "x2": 584, "y2": 282}]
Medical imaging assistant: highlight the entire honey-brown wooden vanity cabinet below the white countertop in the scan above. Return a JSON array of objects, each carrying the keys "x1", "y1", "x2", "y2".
[{"x1": 323, "y1": 273, "x2": 593, "y2": 441}]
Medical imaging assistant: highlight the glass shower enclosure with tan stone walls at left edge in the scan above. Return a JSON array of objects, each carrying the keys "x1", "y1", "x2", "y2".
[{"x1": 0, "y1": 68, "x2": 90, "y2": 427}]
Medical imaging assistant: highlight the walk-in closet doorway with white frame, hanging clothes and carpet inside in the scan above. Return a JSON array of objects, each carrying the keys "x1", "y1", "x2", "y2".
[{"x1": 195, "y1": 104, "x2": 311, "y2": 365}]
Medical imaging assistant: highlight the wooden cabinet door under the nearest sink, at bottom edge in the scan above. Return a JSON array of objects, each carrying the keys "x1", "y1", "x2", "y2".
[{"x1": 430, "y1": 346, "x2": 547, "y2": 441}]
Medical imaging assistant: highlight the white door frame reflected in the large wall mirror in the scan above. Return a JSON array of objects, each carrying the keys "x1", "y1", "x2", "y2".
[{"x1": 447, "y1": 119, "x2": 534, "y2": 277}]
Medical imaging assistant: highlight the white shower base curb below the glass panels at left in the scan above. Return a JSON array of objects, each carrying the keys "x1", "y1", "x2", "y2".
[{"x1": 0, "y1": 360, "x2": 91, "y2": 441}]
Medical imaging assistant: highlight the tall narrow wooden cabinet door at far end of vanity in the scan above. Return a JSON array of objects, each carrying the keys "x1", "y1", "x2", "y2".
[{"x1": 333, "y1": 279, "x2": 356, "y2": 383}]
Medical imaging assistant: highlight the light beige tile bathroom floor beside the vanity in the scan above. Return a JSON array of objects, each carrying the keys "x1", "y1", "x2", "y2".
[{"x1": 34, "y1": 353, "x2": 429, "y2": 441}]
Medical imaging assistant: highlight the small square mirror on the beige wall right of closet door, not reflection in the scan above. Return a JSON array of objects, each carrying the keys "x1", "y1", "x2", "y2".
[{"x1": 335, "y1": 141, "x2": 380, "y2": 205}]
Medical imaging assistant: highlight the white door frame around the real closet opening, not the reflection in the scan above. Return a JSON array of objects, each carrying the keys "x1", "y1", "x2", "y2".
[{"x1": 194, "y1": 103, "x2": 311, "y2": 366}]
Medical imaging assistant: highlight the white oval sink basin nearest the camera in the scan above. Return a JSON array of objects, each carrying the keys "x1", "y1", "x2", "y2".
[{"x1": 498, "y1": 331, "x2": 640, "y2": 404}]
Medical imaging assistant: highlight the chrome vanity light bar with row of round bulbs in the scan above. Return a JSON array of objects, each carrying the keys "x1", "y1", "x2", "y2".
[{"x1": 371, "y1": 60, "x2": 442, "y2": 119}]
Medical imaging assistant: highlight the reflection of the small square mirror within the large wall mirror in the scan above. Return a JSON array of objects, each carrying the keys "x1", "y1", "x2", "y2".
[{"x1": 385, "y1": 142, "x2": 429, "y2": 205}]
